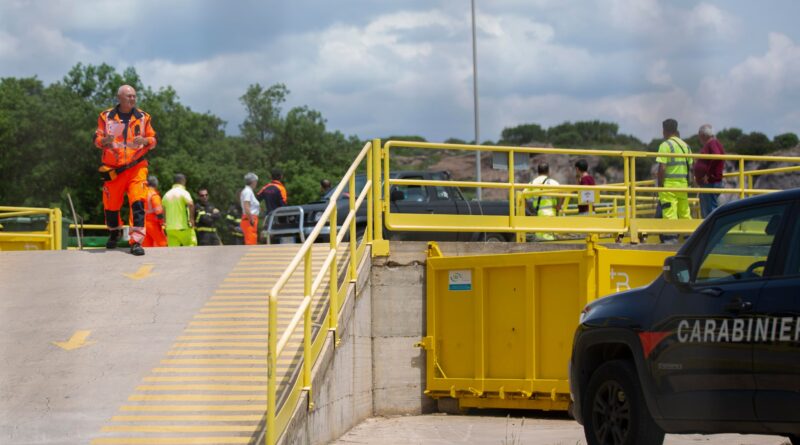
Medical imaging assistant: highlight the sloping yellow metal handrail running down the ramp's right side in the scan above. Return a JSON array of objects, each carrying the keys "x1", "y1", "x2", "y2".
[{"x1": 265, "y1": 142, "x2": 382, "y2": 444}]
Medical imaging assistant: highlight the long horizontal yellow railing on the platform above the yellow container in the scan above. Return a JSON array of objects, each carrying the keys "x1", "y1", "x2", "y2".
[{"x1": 374, "y1": 141, "x2": 800, "y2": 243}]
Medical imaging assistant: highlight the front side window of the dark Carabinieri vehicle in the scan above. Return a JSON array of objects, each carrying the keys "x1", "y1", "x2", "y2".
[{"x1": 695, "y1": 205, "x2": 787, "y2": 283}]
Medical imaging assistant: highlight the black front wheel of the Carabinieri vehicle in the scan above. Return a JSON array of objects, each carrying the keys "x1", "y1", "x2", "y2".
[{"x1": 581, "y1": 360, "x2": 664, "y2": 445}]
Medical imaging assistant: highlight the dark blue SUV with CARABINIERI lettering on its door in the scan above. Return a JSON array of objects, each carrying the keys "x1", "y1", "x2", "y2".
[{"x1": 570, "y1": 189, "x2": 800, "y2": 445}]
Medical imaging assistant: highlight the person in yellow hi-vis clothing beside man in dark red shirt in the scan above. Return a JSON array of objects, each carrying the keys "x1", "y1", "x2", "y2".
[{"x1": 656, "y1": 119, "x2": 692, "y2": 241}]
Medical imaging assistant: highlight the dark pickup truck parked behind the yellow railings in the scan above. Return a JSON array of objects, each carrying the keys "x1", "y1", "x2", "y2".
[{"x1": 263, "y1": 171, "x2": 514, "y2": 243}]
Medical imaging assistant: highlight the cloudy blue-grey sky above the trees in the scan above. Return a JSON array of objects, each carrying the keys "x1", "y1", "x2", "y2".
[{"x1": 0, "y1": 0, "x2": 800, "y2": 140}]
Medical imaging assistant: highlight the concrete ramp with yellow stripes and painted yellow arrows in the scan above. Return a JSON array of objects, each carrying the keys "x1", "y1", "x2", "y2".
[{"x1": 0, "y1": 245, "x2": 338, "y2": 445}]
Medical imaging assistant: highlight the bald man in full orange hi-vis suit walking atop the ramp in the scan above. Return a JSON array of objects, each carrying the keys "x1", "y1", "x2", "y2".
[{"x1": 94, "y1": 85, "x2": 157, "y2": 255}]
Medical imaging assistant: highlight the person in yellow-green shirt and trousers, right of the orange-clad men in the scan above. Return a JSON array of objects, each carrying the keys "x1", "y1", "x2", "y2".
[{"x1": 161, "y1": 173, "x2": 197, "y2": 247}]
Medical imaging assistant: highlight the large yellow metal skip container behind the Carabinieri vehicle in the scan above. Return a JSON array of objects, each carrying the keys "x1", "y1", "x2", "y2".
[{"x1": 418, "y1": 237, "x2": 672, "y2": 410}]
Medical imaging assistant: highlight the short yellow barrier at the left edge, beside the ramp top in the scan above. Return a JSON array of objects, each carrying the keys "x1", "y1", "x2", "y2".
[{"x1": 0, "y1": 206, "x2": 62, "y2": 251}]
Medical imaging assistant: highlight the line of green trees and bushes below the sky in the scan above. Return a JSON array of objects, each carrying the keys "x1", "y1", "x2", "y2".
[{"x1": 0, "y1": 64, "x2": 798, "y2": 222}]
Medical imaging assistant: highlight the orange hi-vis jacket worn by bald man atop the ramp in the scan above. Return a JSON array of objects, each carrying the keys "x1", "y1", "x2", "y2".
[{"x1": 94, "y1": 106, "x2": 158, "y2": 168}]
